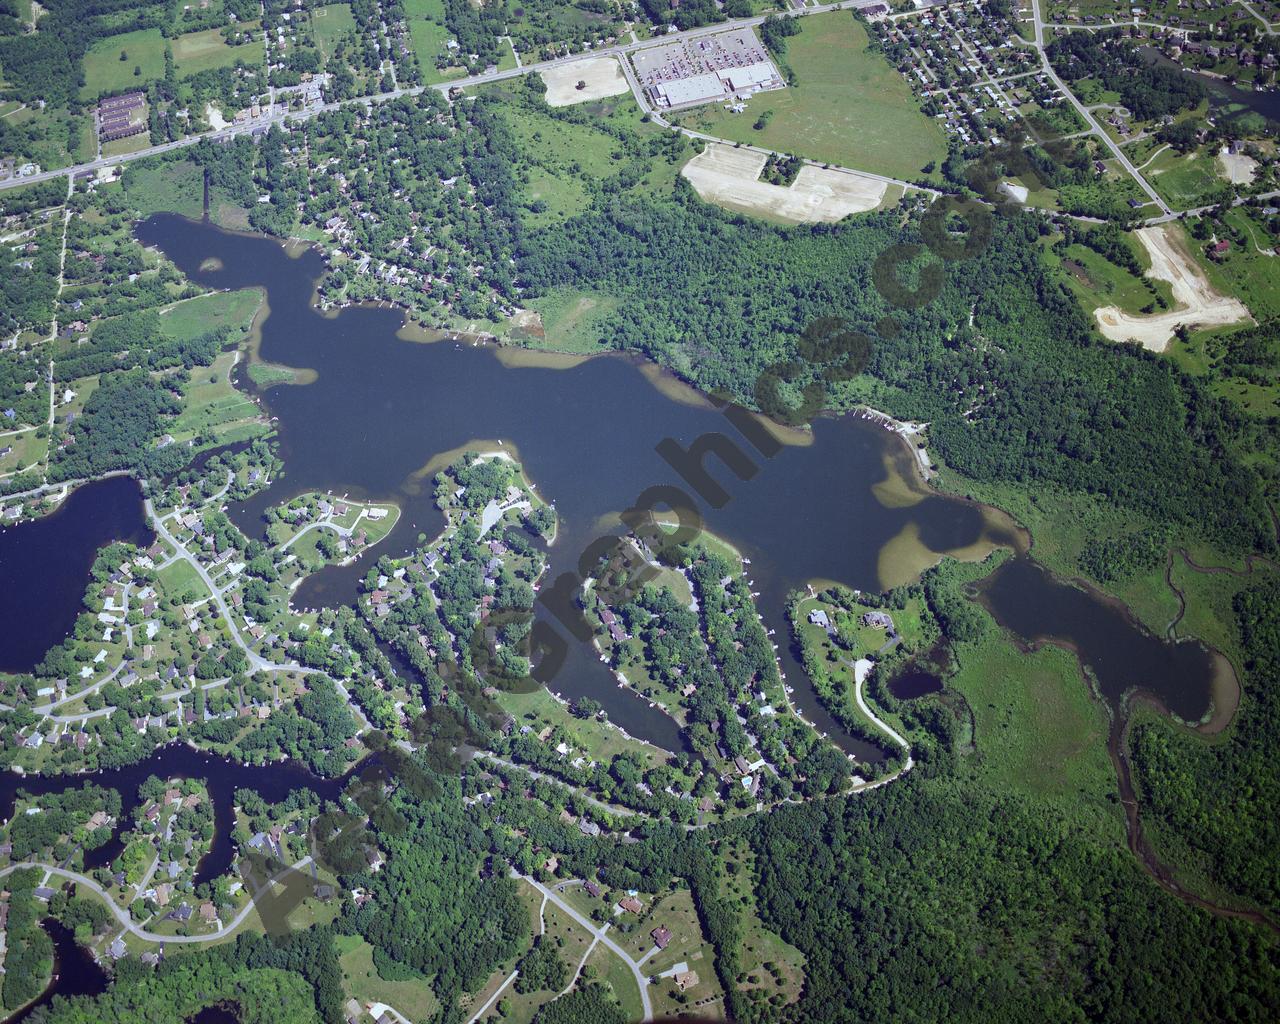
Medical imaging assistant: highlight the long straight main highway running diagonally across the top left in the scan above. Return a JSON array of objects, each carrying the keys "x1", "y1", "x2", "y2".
[{"x1": 0, "y1": 0, "x2": 882, "y2": 191}]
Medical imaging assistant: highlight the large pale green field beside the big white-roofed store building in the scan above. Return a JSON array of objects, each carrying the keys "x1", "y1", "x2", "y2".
[{"x1": 678, "y1": 10, "x2": 947, "y2": 179}]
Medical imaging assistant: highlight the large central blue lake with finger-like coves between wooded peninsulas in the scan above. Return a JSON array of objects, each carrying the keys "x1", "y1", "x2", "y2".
[{"x1": 137, "y1": 214, "x2": 1012, "y2": 760}]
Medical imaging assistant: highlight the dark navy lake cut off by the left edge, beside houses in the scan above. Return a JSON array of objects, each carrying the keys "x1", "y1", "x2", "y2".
[{"x1": 0, "y1": 476, "x2": 152, "y2": 672}]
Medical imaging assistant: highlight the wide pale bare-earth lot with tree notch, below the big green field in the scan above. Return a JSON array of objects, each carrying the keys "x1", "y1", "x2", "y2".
[{"x1": 680, "y1": 142, "x2": 884, "y2": 224}]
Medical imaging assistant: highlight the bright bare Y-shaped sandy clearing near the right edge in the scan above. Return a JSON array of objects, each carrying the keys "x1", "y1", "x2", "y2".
[{"x1": 1093, "y1": 224, "x2": 1253, "y2": 352}]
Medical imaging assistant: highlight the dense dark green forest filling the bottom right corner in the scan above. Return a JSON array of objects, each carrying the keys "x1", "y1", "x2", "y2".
[{"x1": 744, "y1": 772, "x2": 1280, "y2": 1024}]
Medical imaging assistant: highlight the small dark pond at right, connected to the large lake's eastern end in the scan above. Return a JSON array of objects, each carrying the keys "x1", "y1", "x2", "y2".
[{"x1": 980, "y1": 558, "x2": 1215, "y2": 722}]
